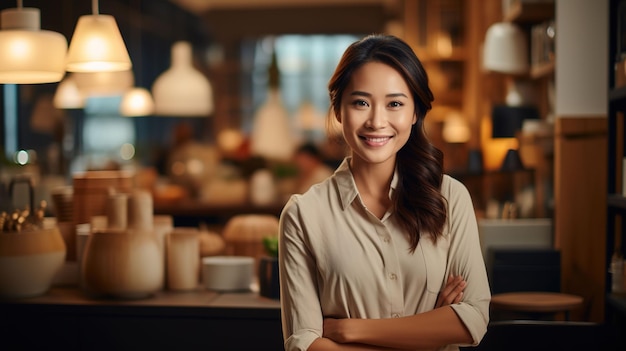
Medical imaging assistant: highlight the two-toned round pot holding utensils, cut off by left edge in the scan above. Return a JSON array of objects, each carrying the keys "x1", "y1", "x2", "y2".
[{"x1": 0, "y1": 227, "x2": 67, "y2": 298}]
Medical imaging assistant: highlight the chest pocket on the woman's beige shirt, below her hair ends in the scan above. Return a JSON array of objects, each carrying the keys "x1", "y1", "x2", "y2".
[{"x1": 418, "y1": 235, "x2": 450, "y2": 294}]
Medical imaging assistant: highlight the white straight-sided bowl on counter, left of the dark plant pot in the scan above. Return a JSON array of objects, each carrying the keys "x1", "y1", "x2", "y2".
[{"x1": 202, "y1": 256, "x2": 254, "y2": 291}]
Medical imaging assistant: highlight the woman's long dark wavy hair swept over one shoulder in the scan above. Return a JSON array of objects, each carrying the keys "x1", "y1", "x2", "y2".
[{"x1": 328, "y1": 35, "x2": 447, "y2": 252}]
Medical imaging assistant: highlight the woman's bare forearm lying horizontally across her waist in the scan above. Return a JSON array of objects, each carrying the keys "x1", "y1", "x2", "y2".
[{"x1": 325, "y1": 306, "x2": 472, "y2": 350}]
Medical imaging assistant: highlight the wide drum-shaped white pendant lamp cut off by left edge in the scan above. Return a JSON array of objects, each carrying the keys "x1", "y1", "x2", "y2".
[{"x1": 0, "y1": 0, "x2": 67, "y2": 84}]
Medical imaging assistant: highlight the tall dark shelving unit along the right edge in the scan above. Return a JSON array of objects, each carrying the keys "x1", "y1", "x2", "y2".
[{"x1": 605, "y1": 0, "x2": 626, "y2": 342}]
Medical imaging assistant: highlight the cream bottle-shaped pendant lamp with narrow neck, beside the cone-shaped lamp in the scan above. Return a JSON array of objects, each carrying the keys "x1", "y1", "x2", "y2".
[{"x1": 152, "y1": 41, "x2": 213, "y2": 117}]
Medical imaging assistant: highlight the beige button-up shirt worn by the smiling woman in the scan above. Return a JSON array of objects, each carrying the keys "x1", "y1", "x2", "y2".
[{"x1": 279, "y1": 159, "x2": 491, "y2": 351}]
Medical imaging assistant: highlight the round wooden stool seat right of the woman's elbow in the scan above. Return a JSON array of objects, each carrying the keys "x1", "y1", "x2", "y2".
[{"x1": 491, "y1": 291, "x2": 583, "y2": 320}]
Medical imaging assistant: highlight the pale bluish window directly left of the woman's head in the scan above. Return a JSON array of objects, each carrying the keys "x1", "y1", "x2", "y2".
[{"x1": 241, "y1": 34, "x2": 361, "y2": 141}]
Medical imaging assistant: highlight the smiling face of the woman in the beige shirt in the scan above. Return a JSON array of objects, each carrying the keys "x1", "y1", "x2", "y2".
[{"x1": 338, "y1": 62, "x2": 417, "y2": 168}]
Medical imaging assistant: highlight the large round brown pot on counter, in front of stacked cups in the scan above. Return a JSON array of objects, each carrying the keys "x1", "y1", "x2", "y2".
[{"x1": 81, "y1": 229, "x2": 164, "y2": 299}]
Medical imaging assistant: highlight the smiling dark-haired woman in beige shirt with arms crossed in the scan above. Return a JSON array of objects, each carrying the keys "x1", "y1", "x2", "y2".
[{"x1": 279, "y1": 35, "x2": 491, "y2": 351}]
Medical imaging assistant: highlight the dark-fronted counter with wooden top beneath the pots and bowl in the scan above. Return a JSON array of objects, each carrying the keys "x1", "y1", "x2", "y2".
[{"x1": 0, "y1": 287, "x2": 283, "y2": 351}]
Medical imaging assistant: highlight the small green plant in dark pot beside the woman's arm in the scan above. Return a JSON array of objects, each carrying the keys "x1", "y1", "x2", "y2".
[{"x1": 259, "y1": 235, "x2": 280, "y2": 300}]
